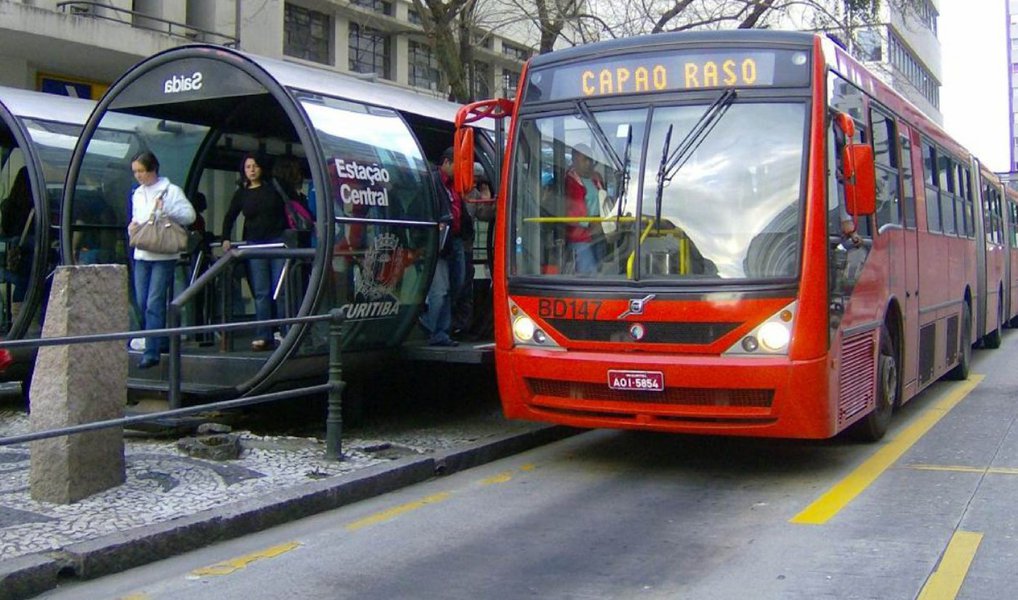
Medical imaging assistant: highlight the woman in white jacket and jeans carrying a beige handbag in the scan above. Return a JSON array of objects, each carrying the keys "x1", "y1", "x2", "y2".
[{"x1": 127, "y1": 152, "x2": 194, "y2": 369}]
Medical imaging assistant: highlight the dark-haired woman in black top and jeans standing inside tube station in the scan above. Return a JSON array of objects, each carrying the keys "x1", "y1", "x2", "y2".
[{"x1": 223, "y1": 154, "x2": 286, "y2": 350}]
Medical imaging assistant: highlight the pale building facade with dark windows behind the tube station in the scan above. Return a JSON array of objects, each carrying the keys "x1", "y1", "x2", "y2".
[{"x1": 0, "y1": 0, "x2": 531, "y2": 99}]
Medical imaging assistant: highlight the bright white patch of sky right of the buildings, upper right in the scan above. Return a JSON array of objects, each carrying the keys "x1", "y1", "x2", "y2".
[{"x1": 938, "y1": 0, "x2": 1011, "y2": 171}]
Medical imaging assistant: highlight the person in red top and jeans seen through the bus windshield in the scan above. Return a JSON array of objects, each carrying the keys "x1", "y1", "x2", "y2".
[{"x1": 565, "y1": 144, "x2": 605, "y2": 274}]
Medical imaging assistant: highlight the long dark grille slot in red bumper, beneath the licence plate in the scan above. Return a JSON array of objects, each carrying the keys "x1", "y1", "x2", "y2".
[{"x1": 526, "y1": 378, "x2": 774, "y2": 408}]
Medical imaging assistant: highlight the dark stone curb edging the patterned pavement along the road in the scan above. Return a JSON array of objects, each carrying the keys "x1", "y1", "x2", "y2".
[{"x1": 0, "y1": 426, "x2": 579, "y2": 600}]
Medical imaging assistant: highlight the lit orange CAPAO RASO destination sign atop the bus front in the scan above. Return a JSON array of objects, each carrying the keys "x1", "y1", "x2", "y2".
[{"x1": 527, "y1": 49, "x2": 809, "y2": 102}]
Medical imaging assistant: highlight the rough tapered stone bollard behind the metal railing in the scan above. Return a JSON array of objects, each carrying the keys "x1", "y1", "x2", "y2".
[{"x1": 30, "y1": 265, "x2": 130, "y2": 504}]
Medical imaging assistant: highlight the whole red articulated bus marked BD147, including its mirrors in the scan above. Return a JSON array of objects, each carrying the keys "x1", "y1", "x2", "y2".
[{"x1": 457, "y1": 31, "x2": 1015, "y2": 439}]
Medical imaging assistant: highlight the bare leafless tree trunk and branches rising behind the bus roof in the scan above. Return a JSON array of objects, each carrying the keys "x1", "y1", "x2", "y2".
[{"x1": 413, "y1": 0, "x2": 927, "y2": 102}]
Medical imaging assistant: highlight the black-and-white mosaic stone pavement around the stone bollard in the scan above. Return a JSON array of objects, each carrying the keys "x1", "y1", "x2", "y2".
[{"x1": 0, "y1": 395, "x2": 527, "y2": 561}]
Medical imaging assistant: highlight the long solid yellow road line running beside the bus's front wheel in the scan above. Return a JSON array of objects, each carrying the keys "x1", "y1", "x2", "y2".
[{"x1": 790, "y1": 375, "x2": 984, "y2": 525}]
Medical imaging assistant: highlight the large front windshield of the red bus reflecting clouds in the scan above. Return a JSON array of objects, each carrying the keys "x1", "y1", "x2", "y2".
[{"x1": 508, "y1": 99, "x2": 806, "y2": 282}]
